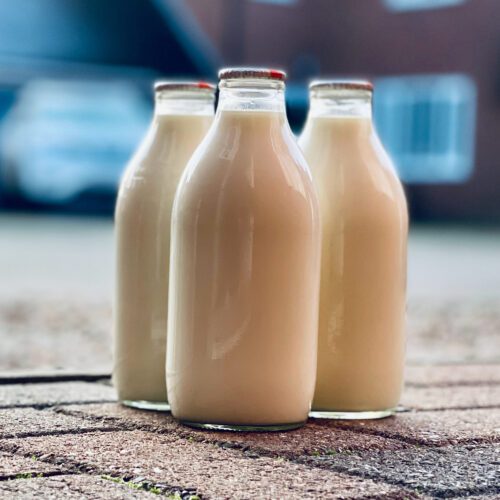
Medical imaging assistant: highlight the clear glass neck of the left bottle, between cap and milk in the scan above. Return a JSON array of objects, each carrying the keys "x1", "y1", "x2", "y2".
[{"x1": 154, "y1": 91, "x2": 215, "y2": 117}]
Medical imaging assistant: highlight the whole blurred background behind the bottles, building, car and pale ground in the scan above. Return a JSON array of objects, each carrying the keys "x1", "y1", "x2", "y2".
[{"x1": 0, "y1": 0, "x2": 500, "y2": 372}]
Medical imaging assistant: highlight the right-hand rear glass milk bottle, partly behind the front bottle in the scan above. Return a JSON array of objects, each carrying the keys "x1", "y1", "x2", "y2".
[{"x1": 299, "y1": 81, "x2": 408, "y2": 419}]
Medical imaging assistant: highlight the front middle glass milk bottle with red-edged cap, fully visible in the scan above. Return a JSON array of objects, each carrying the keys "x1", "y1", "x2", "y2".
[{"x1": 167, "y1": 69, "x2": 320, "y2": 430}]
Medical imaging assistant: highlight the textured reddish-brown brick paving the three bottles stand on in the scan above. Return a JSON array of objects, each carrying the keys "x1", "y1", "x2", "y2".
[{"x1": 0, "y1": 364, "x2": 500, "y2": 500}]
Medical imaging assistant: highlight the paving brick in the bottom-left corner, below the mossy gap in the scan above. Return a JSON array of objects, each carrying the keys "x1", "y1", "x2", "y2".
[{"x1": 0, "y1": 475, "x2": 158, "y2": 500}]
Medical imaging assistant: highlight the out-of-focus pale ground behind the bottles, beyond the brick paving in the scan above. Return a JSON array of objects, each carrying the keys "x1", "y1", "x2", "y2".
[{"x1": 0, "y1": 215, "x2": 500, "y2": 373}]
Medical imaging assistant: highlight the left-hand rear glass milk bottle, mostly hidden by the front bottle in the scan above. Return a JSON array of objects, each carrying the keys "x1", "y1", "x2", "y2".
[{"x1": 113, "y1": 82, "x2": 215, "y2": 409}]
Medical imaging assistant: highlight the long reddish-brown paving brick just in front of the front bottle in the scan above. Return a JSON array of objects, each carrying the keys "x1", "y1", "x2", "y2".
[{"x1": 2, "y1": 431, "x2": 412, "y2": 499}]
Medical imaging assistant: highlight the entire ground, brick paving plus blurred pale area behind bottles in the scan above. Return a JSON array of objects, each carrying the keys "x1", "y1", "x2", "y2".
[{"x1": 0, "y1": 217, "x2": 500, "y2": 500}]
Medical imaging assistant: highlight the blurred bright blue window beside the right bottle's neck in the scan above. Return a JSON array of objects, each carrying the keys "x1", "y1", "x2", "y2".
[{"x1": 374, "y1": 74, "x2": 476, "y2": 183}]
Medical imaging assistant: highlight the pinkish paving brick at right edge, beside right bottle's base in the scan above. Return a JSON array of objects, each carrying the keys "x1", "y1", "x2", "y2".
[{"x1": 401, "y1": 384, "x2": 500, "y2": 410}]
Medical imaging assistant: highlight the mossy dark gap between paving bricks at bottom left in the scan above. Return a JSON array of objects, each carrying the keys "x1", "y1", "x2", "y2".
[{"x1": 0, "y1": 442, "x2": 203, "y2": 498}]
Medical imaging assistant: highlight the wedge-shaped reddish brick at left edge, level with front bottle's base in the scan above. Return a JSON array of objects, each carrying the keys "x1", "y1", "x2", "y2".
[{"x1": 0, "y1": 408, "x2": 118, "y2": 439}]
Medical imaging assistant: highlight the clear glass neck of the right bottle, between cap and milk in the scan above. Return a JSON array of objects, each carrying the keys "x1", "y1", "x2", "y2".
[{"x1": 309, "y1": 91, "x2": 372, "y2": 120}]
